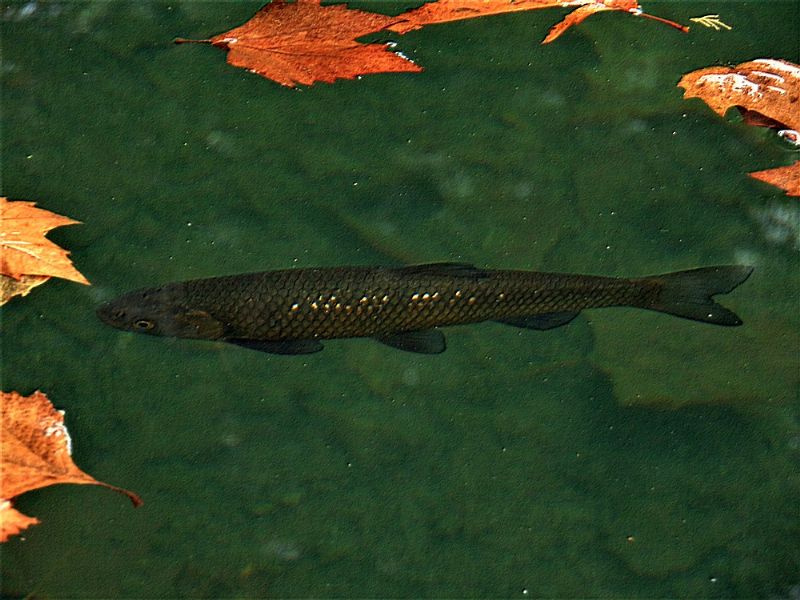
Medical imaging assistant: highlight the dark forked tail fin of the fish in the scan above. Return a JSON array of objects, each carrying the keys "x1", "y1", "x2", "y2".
[{"x1": 647, "y1": 265, "x2": 753, "y2": 327}]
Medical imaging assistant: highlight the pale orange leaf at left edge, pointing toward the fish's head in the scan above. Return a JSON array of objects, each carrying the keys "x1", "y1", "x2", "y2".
[{"x1": 0, "y1": 197, "x2": 89, "y2": 285}]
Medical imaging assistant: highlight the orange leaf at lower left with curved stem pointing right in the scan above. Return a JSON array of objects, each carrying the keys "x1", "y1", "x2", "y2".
[{"x1": 0, "y1": 391, "x2": 142, "y2": 542}]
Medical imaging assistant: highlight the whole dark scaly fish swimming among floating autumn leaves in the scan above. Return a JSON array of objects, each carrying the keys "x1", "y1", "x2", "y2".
[{"x1": 97, "y1": 263, "x2": 753, "y2": 355}]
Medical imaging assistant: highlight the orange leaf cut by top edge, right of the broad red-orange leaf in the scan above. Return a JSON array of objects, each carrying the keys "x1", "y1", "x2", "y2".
[{"x1": 389, "y1": 0, "x2": 689, "y2": 44}]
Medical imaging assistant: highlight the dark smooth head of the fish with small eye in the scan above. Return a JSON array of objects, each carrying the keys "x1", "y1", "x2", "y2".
[{"x1": 97, "y1": 286, "x2": 225, "y2": 340}]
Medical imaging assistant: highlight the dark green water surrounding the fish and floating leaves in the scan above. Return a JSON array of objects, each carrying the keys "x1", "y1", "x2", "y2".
[{"x1": 0, "y1": 2, "x2": 800, "y2": 599}]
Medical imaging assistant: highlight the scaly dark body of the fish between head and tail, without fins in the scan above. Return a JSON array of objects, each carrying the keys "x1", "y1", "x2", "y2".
[{"x1": 184, "y1": 269, "x2": 658, "y2": 340}]
